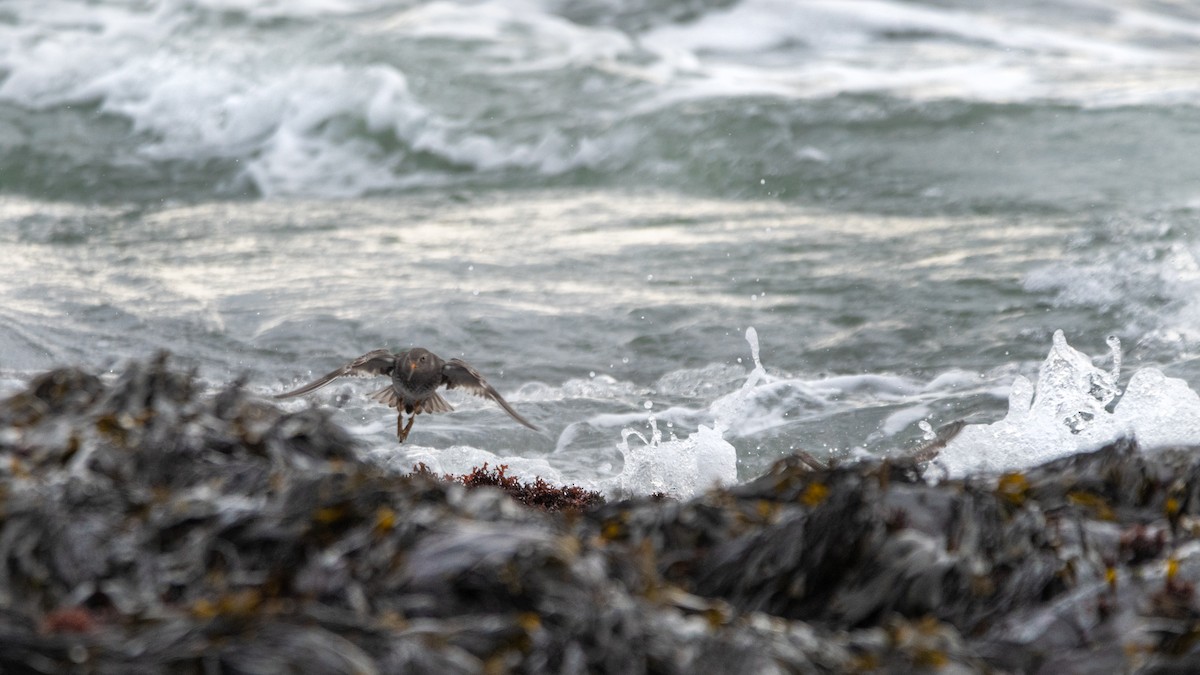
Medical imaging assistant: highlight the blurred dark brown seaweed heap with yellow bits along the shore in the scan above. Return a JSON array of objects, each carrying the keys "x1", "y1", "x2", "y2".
[{"x1": 0, "y1": 357, "x2": 1200, "y2": 674}]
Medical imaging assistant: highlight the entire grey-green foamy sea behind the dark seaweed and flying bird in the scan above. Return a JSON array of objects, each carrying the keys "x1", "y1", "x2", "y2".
[{"x1": 0, "y1": 0, "x2": 1200, "y2": 496}]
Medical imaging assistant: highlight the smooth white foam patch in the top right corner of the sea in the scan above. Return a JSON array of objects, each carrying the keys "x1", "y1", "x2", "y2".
[{"x1": 643, "y1": 0, "x2": 1200, "y2": 104}]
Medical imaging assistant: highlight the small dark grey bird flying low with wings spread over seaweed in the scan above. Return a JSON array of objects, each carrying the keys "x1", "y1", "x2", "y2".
[{"x1": 275, "y1": 347, "x2": 540, "y2": 443}]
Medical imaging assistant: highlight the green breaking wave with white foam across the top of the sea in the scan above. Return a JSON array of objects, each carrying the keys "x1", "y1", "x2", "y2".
[{"x1": 0, "y1": 0, "x2": 1200, "y2": 204}]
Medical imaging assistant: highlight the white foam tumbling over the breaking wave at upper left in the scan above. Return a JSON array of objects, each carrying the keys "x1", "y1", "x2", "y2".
[{"x1": 0, "y1": 0, "x2": 629, "y2": 197}]
